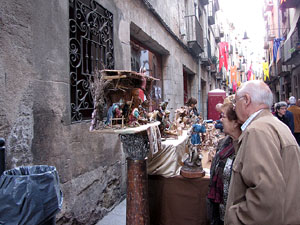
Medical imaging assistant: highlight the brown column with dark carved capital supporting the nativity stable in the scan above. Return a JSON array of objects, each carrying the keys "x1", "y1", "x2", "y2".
[{"x1": 120, "y1": 132, "x2": 150, "y2": 225}]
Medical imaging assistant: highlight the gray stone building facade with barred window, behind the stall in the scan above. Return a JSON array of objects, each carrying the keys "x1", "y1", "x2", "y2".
[{"x1": 0, "y1": 0, "x2": 222, "y2": 225}]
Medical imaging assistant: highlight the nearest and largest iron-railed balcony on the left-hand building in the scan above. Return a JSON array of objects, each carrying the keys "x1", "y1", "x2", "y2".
[{"x1": 185, "y1": 15, "x2": 204, "y2": 56}]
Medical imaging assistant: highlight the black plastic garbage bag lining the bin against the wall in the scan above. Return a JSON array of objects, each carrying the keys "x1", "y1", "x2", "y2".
[{"x1": 0, "y1": 165, "x2": 63, "y2": 225}]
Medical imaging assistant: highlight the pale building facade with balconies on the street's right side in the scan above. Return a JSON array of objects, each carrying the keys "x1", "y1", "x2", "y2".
[{"x1": 264, "y1": 0, "x2": 300, "y2": 102}]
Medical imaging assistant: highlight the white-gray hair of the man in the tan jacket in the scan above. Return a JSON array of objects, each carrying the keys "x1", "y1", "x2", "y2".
[{"x1": 237, "y1": 80, "x2": 273, "y2": 109}]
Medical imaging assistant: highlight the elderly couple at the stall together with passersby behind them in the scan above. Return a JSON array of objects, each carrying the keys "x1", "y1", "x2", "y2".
[{"x1": 207, "y1": 80, "x2": 300, "y2": 225}]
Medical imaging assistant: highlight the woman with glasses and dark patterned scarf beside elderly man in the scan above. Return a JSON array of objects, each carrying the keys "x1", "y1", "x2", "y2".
[{"x1": 207, "y1": 101, "x2": 242, "y2": 225}]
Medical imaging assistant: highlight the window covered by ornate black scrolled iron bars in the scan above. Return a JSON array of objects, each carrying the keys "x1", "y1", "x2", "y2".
[{"x1": 69, "y1": 0, "x2": 115, "y2": 123}]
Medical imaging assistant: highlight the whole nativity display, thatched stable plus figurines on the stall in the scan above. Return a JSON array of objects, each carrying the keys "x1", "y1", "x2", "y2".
[{"x1": 90, "y1": 70, "x2": 225, "y2": 178}]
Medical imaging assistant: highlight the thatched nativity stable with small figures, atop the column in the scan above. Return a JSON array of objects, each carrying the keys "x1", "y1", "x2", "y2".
[{"x1": 90, "y1": 70, "x2": 157, "y2": 131}]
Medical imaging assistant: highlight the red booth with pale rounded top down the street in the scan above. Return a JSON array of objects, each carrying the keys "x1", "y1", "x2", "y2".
[{"x1": 207, "y1": 89, "x2": 226, "y2": 120}]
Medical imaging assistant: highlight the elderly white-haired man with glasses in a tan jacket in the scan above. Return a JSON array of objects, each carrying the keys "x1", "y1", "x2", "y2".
[{"x1": 225, "y1": 81, "x2": 300, "y2": 225}]
